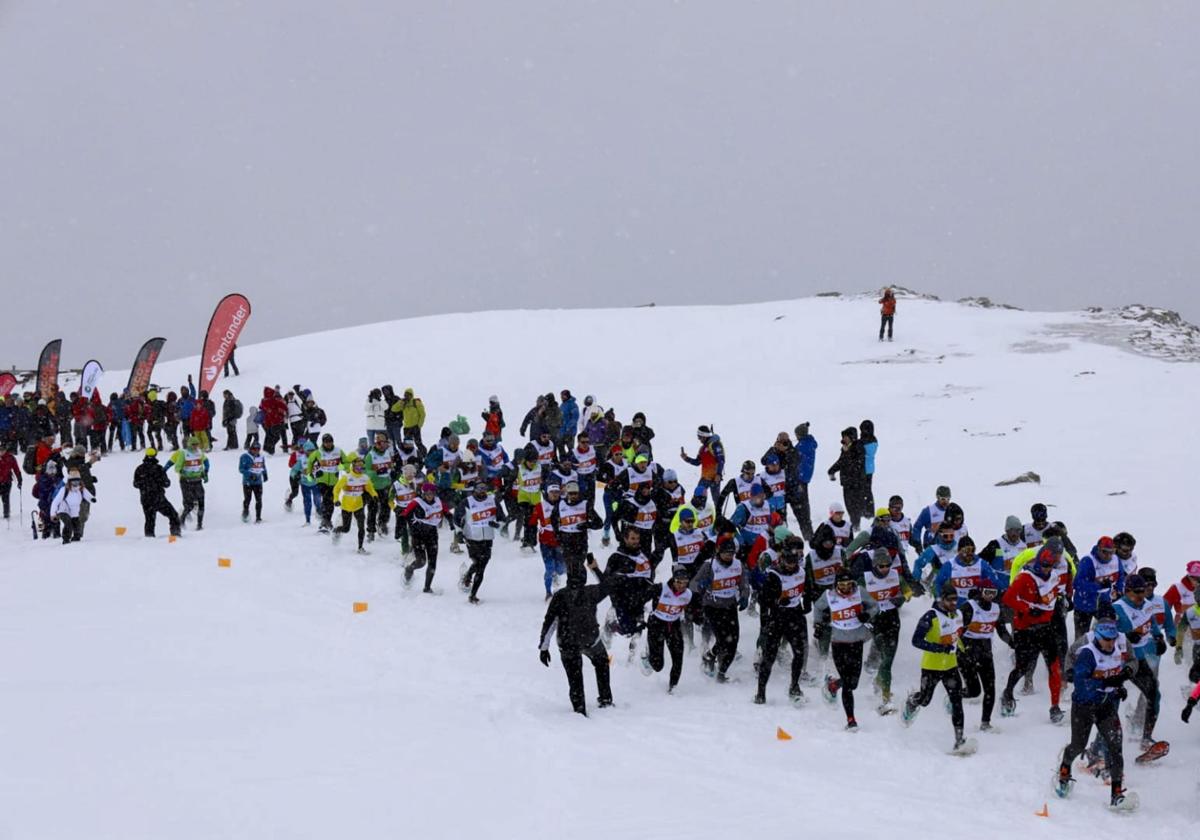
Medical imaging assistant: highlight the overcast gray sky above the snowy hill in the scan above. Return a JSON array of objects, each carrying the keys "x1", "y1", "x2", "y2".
[{"x1": 0, "y1": 0, "x2": 1200, "y2": 368}]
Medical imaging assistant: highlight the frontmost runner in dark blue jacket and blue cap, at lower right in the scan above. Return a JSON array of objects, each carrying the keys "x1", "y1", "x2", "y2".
[{"x1": 1056, "y1": 620, "x2": 1134, "y2": 808}]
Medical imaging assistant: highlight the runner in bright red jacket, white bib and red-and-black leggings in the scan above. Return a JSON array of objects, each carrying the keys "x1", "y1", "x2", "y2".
[{"x1": 1000, "y1": 536, "x2": 1063, "y2": 724}]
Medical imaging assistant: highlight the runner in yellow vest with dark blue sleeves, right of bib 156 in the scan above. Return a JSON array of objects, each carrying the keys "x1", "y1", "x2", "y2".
[{"x1": 900, "y1": 587, "x2": 974, "y2": 754}]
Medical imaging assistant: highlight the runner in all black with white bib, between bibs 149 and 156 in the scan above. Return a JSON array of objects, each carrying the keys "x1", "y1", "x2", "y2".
[{"x1": 754, "y1": 534, "x2": 812, "y2": 704}]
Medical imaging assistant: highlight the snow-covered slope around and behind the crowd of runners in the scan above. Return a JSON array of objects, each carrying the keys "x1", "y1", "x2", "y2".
[{"x1": 0, "y1": 299, "x2": 1200, "y2": 838}]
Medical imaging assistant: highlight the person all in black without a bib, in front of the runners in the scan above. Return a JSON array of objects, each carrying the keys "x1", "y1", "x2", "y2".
[{"x1": 538, "y1": 556, "x2": 612, "y2": 718}]
